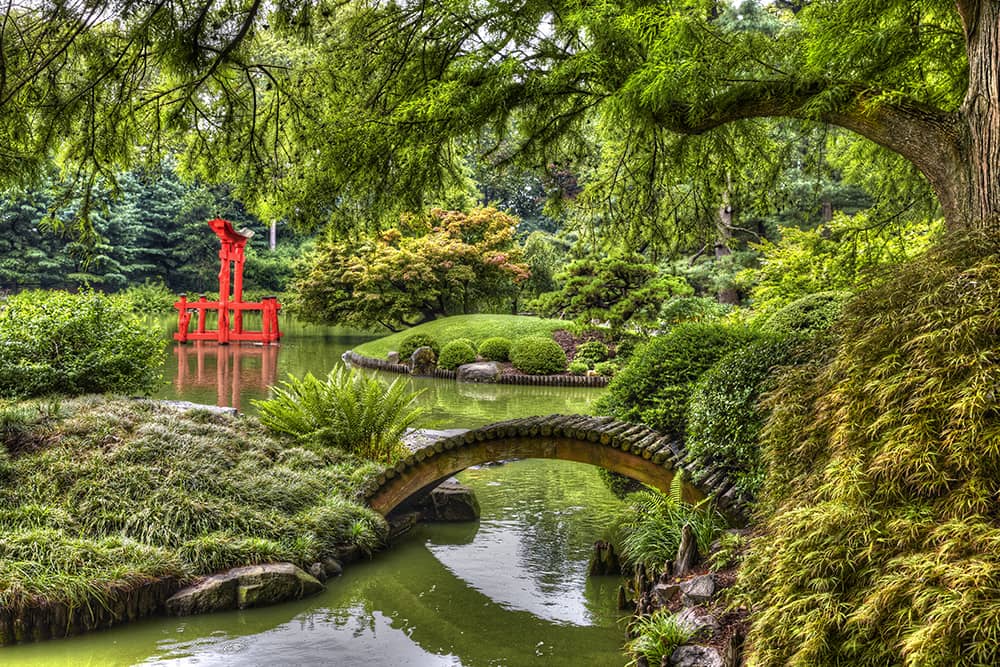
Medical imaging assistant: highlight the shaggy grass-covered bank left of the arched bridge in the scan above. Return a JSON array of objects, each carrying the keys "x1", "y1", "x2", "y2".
[{"x1": 0, "y1": 396, "x2": 385, "y2": 620}]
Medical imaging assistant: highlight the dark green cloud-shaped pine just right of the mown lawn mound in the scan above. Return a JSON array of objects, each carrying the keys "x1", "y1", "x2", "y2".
[{"x1": 531, "y1": 252, "x2": 692, "y2": 328}]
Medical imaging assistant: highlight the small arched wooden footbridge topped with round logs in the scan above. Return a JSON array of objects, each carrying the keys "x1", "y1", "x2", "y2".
[{"x1": 366, "y1": 415, "x2": 746, "y2": 522}]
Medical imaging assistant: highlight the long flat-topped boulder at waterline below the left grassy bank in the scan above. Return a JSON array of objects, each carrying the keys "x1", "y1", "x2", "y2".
[{"x1": 166, "y1": 563, "x2": 324, "y2": 616}]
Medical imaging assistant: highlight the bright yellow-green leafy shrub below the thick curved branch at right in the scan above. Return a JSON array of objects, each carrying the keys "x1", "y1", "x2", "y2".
[{"x1": 740, "y1": 213, "x2": 939, "y2": 315}]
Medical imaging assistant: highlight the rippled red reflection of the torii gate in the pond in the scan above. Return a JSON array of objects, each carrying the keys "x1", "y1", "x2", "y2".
[{"x1": 174, "y1": 341, "x2": 279, "y2": 411}]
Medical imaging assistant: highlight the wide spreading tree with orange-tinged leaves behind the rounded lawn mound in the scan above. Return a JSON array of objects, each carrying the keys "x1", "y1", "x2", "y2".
[{"x1": 295, "y1": 208, "x2": 529, "y2": 331}]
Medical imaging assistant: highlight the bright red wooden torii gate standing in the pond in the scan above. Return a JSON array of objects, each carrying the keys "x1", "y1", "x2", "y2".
[{"x1": 174, "y1": 218, "x2": 281, "y2": 345}]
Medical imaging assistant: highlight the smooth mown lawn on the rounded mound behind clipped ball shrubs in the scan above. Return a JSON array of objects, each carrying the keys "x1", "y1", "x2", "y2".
[{"x1": 354, "y1": 315, "x2": 573, "y2": 359}]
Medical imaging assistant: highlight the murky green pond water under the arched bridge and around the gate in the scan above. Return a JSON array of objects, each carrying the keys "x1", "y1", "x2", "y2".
[{"x1": 0, "y1": 320, "x2": 624, "y2": 667}]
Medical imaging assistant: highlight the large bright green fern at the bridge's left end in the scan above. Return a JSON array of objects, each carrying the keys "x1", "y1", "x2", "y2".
[{"x1": 254, "y1": 367, "x2": 423, "y2": 463}]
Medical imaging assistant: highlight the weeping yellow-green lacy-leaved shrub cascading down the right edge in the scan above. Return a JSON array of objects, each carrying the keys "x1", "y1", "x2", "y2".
[{"x1": 740, "y1": 237, "x2": 1000, "y2": 667}]
